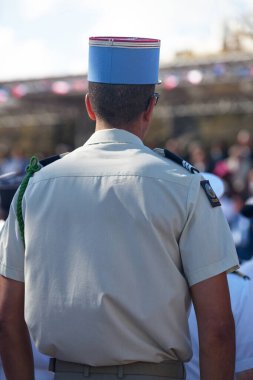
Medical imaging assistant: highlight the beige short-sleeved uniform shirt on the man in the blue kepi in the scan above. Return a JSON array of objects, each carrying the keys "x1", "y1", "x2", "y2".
[{"x1": 0, "y1": 129, "x2": 238, "y2": 365}]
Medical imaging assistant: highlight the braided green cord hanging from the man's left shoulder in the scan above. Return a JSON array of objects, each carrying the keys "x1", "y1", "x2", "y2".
[{"x1": 16, "y1": 156, "x2": 42, "y2": 246}]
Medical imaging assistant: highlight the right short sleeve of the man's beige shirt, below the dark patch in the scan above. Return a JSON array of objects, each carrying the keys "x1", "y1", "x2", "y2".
[{"x1": 179, "y1": 174, "x2": 238, "y2": 286}]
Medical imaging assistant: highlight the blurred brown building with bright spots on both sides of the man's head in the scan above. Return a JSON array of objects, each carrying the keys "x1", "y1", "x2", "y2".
[{"x1": 0, "y1": 13, "x2": 253, "y2": 155}]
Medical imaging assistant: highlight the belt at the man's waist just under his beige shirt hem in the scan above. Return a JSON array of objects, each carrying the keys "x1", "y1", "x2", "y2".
[{"x1": 49, "y1": 359, "x2": 185, "y2": 379}]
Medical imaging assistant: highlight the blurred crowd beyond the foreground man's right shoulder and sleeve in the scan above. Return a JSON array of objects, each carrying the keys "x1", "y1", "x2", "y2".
[{"x1": 166, "y1": 130, "x2": 253, "y2": 262}]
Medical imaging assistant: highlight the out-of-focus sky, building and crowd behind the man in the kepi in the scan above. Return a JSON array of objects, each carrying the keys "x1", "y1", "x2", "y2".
[{"x1": 0, "y1": 0, "x2": 253, "y2": 259}]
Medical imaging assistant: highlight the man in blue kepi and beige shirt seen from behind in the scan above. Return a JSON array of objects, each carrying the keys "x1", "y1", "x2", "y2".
[{"x1": 0, "y1": 37, "x2": 238, "y2": 380}]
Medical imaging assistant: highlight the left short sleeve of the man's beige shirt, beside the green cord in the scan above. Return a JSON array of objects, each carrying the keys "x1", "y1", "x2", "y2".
[{"x1": 0, "y1": 193, "x2": 24, "y2": 282}]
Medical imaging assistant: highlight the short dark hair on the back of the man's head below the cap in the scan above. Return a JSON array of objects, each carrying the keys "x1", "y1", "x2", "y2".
[{"x1": 89, "y1": 82, "x2": 155, "y2": 128}]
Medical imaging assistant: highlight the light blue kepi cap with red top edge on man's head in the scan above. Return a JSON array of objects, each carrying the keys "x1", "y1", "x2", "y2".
[{"x1": 88, "y1": 37, "x2": 160, "y2": 84}]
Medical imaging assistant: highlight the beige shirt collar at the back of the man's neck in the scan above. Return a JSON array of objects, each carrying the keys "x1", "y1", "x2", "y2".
[{"x1": 84, "y1": 128, "x2": 143, "y2": 145}]
